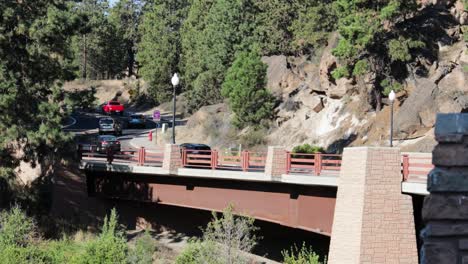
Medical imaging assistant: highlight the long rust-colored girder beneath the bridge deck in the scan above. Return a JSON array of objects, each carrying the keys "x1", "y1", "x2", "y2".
[{"x1": 86, "y1": 171, "x2": 336, "y2": 236}]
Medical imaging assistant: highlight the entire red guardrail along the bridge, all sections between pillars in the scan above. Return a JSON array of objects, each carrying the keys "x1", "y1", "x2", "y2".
[{"x1": 78, "y1": 145, "x2": 434, "y2": 182}]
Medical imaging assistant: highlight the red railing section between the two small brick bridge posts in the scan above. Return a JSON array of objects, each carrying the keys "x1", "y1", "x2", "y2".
[{"x1": 182, "y1": 149, "x2": 266, "y2": 171}]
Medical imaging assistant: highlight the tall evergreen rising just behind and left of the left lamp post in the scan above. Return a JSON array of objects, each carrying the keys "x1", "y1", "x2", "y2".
[{"x1": 137, "y1": 0, "x2": 188, "y2": 102}]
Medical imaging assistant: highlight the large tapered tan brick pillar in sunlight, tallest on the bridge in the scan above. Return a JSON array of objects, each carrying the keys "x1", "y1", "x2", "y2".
[{"x1": 328, "y1": 147, "x2": 418, "y2": 264}]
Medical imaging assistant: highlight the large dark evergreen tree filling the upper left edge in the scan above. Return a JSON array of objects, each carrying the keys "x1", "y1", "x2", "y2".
[{"x1": 0, "y1": 0, "x2": 79, "y2": 179}]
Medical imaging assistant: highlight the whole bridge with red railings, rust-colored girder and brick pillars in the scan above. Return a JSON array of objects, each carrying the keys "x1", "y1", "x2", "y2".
[{"x1": 81, "y1": 144, "x2": 432, "y2": 263}]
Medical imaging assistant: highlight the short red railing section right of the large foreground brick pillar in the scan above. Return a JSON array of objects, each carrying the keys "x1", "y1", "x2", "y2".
[{"x1": 401, "y1": 153, "x2": 434, "y2": 182}]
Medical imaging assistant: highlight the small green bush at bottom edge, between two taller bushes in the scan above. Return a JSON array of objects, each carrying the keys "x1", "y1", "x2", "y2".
[{"x1": 128, "y1": 231, "x2": 156, "y2": 264}]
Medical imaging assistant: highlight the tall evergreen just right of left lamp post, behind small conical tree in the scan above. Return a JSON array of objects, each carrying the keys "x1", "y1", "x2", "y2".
[{"x1": 183, "y1": 0, "x2": 253, "y2": 110}]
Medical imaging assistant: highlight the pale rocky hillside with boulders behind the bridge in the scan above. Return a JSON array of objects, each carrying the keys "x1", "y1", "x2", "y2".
[{"x1": 171, "y1": 1, "x2": 468, "y2": 151}]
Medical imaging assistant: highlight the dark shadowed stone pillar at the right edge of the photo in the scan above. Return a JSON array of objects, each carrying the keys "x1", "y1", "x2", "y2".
[{"x1": 421, "y1": 114, "x2": 468, "y2": 264}]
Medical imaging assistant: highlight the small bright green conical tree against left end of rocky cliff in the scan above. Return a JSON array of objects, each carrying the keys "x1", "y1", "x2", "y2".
[{"x1": 222, "y1": 51, "x2": 274, "y2": 127}]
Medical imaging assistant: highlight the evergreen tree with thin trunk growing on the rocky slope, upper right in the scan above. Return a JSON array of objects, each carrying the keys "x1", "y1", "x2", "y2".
[{"x1": 333, "y1": 0, "x2": 424, "y2": 110}]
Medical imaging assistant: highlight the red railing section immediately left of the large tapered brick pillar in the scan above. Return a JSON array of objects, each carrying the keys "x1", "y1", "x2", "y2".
[{"x1": 286, "y1": 152, "x2": 341, "y2": 176}]
